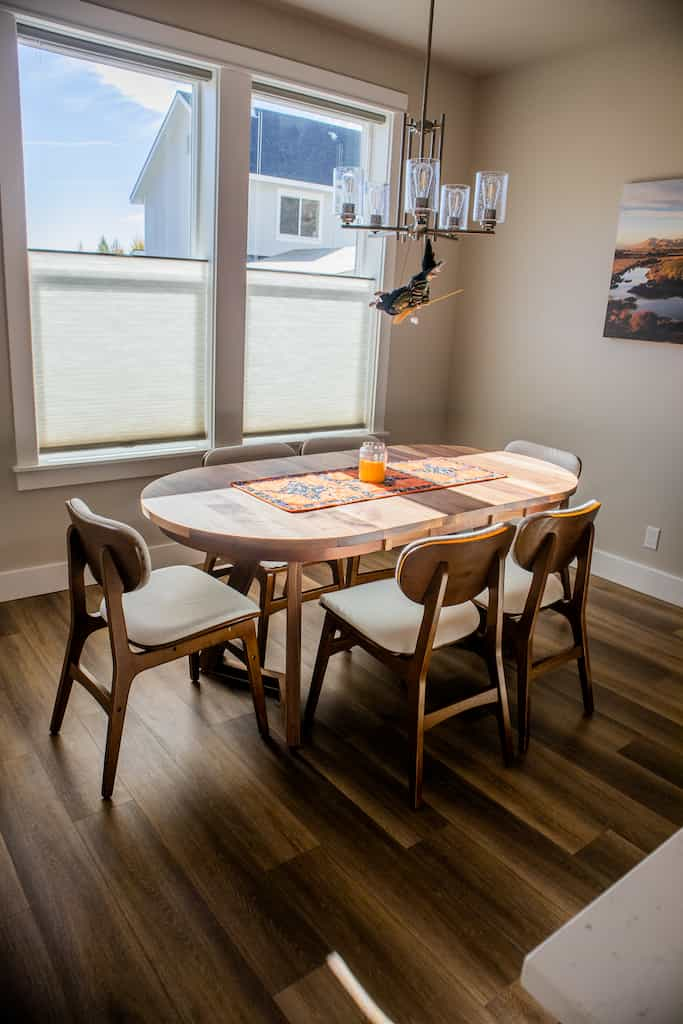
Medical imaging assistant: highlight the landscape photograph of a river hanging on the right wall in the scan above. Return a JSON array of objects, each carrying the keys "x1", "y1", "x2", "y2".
[{"x1": 604, "y1": 178, "x2": 683, "y2": 345}]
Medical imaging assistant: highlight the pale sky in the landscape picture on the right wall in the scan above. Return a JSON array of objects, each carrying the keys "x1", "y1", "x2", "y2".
[{"x1": 616, "y1": 178, "x2": 683, "y2": 247}]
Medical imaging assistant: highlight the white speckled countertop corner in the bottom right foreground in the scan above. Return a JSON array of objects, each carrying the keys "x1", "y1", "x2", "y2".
[{"x1": 521, "y1": 829, "x2": 683, "y2": 1024}]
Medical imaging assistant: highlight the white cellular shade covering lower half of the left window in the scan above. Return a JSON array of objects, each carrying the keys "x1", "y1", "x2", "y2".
[{"x1": 29, "y1": 251, "x2": 208, "y2": 452}]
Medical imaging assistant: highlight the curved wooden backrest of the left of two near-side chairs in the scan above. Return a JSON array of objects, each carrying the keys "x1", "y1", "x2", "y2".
[{"x1": 396, "y1": 522, "x2": 515, "y2": 606}]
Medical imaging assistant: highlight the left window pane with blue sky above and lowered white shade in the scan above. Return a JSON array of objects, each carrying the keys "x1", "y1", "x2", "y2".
[{"x1": 18, "y1": 43, "x2": 211, "y2": 456}]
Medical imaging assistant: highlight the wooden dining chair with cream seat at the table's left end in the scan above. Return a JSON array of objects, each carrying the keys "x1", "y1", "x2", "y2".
[{"x1": 50, "y1": 498, "x2": 268, "y2": 799}]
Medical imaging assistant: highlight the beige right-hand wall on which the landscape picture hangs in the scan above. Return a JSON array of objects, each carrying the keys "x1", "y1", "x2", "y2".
[{"x1": 449, "y1": 31, "x2": 683, "y2": 575}]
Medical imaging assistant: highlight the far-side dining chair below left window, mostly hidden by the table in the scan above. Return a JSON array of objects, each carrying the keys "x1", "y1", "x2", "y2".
[{"x1": 202, "y1": 441, "x2": 345, "y2": 665}]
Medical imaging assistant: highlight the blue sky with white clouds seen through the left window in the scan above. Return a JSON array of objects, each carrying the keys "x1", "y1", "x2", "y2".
[{"x1": 19, "y1": 44, "x2": 191, "y2": 252}]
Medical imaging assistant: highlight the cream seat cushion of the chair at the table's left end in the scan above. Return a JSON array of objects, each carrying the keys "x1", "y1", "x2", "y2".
[{"x1": 99, "y1": 565, "x2": 259, "y2": 647}]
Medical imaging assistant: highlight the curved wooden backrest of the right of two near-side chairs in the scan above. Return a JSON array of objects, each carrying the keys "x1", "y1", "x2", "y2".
[{"x1": 513, "y1": 500, "x2": 600, "y2": 572}]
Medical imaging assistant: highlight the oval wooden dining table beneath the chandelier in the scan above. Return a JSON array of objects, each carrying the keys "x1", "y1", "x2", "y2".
[{"x1": 140, "y1": 444, "x2": 578, "y2": 746}]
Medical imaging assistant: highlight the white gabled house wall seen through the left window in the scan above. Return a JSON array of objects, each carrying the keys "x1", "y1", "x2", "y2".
[{"x1": 130, "y1": 91, "x2": 193, "y2": 257}]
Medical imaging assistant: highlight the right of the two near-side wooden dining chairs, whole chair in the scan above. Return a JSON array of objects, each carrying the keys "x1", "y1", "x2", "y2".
[{"x1": 476, "y1": 501, "x2": 600, "y2": 754}]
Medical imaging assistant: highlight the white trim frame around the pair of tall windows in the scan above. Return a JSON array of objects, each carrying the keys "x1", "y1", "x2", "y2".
[{"x1": 0, "y1": 0, "x2": 408, "y2": 489}]
